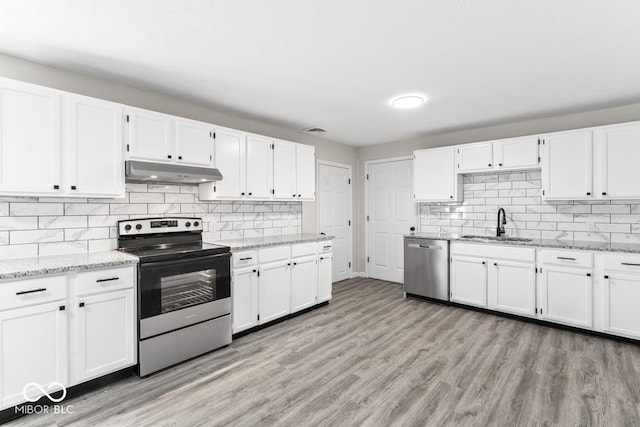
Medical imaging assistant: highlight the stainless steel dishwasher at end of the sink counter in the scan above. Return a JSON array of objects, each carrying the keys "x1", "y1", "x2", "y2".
[{"x1": 404, "y1": 237, "x2": 449, "y2": 301}]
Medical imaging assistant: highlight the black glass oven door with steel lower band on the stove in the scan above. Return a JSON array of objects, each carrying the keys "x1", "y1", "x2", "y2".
[{"x1": 138, "y1": 253, "x2": 231, "y2": 338}]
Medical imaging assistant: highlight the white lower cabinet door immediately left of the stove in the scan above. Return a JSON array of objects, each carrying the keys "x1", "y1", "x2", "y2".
[{"x1": 74, "y1": 289, "x2": 136, "y2": 383}]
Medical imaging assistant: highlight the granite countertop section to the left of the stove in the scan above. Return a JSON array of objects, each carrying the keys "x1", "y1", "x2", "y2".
[{"x1": 0, "y1": 251, "x2": 138, "y2": 280}]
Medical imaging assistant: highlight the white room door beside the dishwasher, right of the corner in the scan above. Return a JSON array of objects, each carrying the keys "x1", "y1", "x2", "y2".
[{"x1": 366, "y1": 160, "x2": 417, "y2": 283}]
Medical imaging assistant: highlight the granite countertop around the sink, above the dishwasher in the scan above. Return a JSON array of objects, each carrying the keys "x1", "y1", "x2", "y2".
[{"x1": 404, "y1": 233, "x2": 640, "y2": 254}]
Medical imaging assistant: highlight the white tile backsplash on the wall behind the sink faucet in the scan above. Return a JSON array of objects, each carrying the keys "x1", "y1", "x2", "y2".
[{"x1": 420, "y1": 171, "x2": 640, "y2": 243}]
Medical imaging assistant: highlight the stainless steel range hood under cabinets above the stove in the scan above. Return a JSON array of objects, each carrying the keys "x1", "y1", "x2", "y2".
[{"x1": 125, "y1": 160, "x2": 222, "y2": 184}]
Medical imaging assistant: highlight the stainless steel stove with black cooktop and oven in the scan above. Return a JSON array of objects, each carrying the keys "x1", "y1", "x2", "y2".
[{"x1": 118, "y1": 218, "x2": 231, "y2": 377}]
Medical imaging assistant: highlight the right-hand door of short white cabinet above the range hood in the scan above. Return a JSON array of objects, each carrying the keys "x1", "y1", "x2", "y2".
[{"x1": 175, "y1": 119, "x2": 213, "y2": 167}]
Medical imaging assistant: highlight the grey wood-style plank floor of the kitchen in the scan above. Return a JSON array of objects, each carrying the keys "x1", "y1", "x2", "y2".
[{"x1": 6, "y1": 279, "x2": 640, "y2": 426}]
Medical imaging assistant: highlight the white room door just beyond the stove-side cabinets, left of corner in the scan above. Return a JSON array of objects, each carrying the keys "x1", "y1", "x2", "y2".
[{"x1": 318, "y1": 163, "x2": 351, "y2": 282}]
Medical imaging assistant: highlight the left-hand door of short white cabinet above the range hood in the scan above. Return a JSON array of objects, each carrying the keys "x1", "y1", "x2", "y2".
[{"x1": 127, "y1": 108, "x2": 173, "y2": 162}]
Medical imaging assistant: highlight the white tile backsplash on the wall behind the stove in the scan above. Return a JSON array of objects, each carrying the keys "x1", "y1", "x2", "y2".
[{"x1": 0, "y1": 184, "x2": 302, "y2": 258}]
